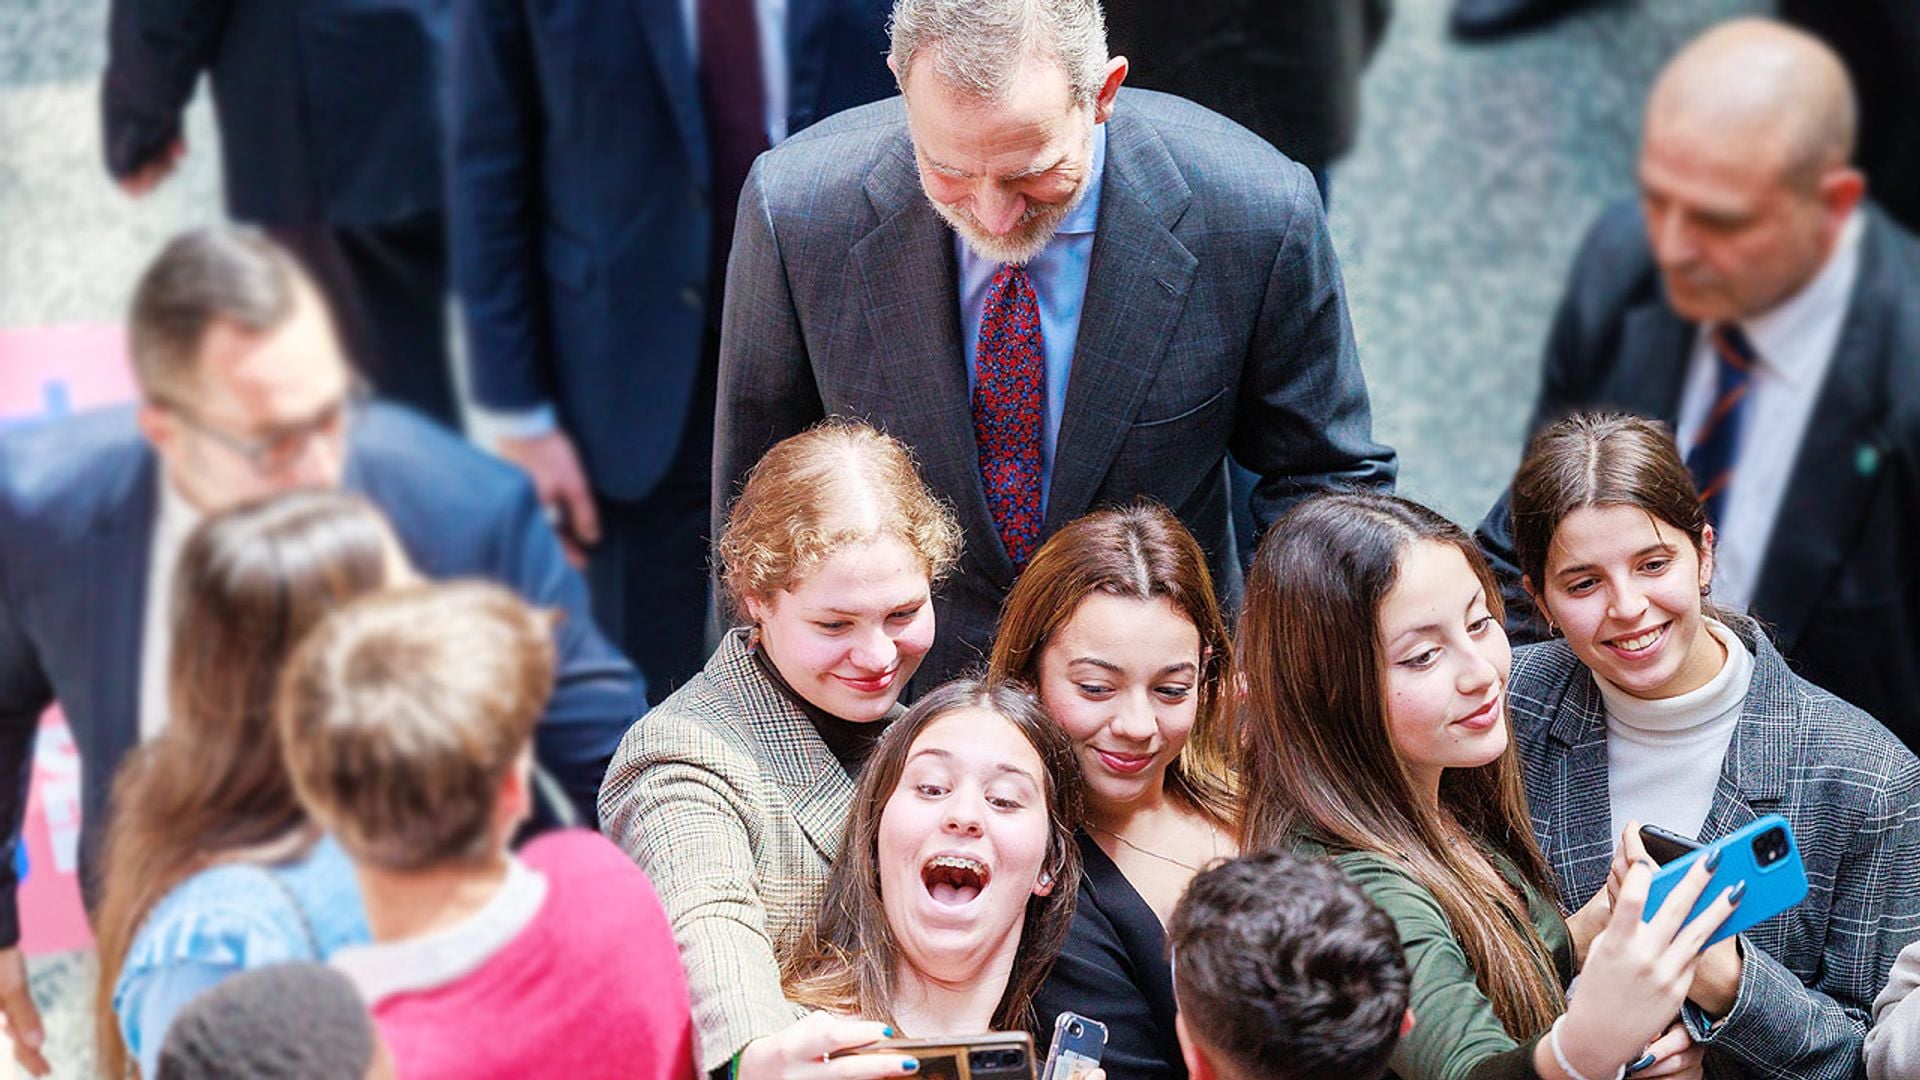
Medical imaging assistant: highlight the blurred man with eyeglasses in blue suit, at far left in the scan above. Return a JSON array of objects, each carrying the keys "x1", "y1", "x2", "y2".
[{"x1": 0, "y1": 227, "x2": 645, "y2": 1072}]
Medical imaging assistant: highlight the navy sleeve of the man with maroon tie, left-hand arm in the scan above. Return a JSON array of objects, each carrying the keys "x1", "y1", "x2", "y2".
[{"x1": 447, "y1": 0, "x2": 553, "y2": 411}]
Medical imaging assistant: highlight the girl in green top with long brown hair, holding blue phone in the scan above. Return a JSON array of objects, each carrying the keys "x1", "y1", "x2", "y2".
[{"x1": 1235, "y1": 494, "x2": 1738, "y2": 1080}]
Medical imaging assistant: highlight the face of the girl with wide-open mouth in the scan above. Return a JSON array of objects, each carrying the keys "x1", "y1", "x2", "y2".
[{"x1": 879, "y1": 709, "x2": 1052, "y2": 984}]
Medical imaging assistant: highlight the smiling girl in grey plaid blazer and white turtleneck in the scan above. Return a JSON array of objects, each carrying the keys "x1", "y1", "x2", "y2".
[{"x1": 1511, "y1": 415, "x2": 1920, "y2": 1080}]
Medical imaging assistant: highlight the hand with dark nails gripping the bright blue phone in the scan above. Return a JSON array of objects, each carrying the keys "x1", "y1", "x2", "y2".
[{"x1": 1559, "y1": 857, "x2": 1734, "y2": 1076}]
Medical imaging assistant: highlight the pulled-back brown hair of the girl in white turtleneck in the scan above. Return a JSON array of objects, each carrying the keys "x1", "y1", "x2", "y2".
[{"x1": 1513, "y1": 413, "x2": 1720, "y2": 617}]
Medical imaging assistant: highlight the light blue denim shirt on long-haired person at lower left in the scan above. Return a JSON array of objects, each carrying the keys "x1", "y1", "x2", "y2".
[{"x1": 113, "y1": 836, "x2": 369, "y2": 1076}]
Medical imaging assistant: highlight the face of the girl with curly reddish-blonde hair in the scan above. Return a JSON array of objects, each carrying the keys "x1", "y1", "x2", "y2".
[{"x1": 747, "y1": 536, "x2": 933, "y2": 723}]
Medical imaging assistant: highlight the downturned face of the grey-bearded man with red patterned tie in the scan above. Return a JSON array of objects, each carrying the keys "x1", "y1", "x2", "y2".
[{"x1": 904, "y1": 49, "x2": 1125, "y2": 265}]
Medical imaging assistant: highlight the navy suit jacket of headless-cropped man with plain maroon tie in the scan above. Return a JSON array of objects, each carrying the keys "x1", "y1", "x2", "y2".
[{"x1": 447, "y1": 0, "x2": 893, "y2": 500}]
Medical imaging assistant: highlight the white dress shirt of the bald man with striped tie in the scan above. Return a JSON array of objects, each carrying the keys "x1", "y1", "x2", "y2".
[{"x1": 1676, "y1": 209, "x2": 1866, "y2": 611}]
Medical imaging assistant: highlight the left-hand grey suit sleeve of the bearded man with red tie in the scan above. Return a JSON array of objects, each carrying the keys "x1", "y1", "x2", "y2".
[{"x1": 712, "y1": 156, "x2": 826, "y2": 536}]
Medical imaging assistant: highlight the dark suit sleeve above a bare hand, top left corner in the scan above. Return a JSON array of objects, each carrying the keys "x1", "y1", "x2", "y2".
[{"x1": 100, "y1": 0, "x2": 228, "y2": 179}]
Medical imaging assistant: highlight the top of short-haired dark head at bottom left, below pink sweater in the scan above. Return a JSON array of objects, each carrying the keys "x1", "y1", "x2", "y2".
[{"x1": 156, "y1": 963, "x2": 394, "y2": 1080}]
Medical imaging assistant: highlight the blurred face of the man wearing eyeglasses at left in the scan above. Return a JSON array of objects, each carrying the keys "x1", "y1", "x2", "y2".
[{"x1": 140, "y1": 286, "x2": 349, "y2": 513}]
